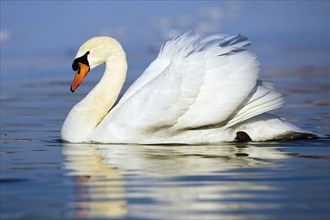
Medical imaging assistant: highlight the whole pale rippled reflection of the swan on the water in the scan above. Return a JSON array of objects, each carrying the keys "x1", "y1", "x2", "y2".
[{"x1": 63, "y1": 143, "x2": 286, "y2": 219}]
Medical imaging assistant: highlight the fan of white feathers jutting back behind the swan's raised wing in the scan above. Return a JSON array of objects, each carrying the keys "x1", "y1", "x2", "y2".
[{"x1": 225, "y1": 81, "x2": 283, "y2": 127}]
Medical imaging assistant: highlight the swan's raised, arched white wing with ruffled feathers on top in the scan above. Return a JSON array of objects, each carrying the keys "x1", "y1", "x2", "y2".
[{"x1": 97, "y1": 33, "x2": 282, "y2": 139}]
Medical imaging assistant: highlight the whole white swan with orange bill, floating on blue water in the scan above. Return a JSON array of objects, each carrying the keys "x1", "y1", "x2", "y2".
[{"x1": 61, "y1": 32, "x2": 316, "y2": 144}]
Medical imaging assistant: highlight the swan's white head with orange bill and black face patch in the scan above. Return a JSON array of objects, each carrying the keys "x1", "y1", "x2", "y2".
[{"x1": 71, "y1": 37, "x2": 121, "y2": 92}]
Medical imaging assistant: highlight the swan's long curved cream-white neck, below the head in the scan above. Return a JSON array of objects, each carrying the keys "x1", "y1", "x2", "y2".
[{"x1": 61, "y1": 43, "x2": 127, "y2": 142}]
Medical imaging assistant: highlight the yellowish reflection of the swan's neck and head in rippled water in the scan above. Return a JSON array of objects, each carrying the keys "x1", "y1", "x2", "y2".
[{"x1": 63, "y1": 145, "x2": 126, "y2": 218}]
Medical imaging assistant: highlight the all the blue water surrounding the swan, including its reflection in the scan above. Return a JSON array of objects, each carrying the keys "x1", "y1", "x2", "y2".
[{"x1": 0, "y1": 1, "x2": 330, "y2": 220}]
